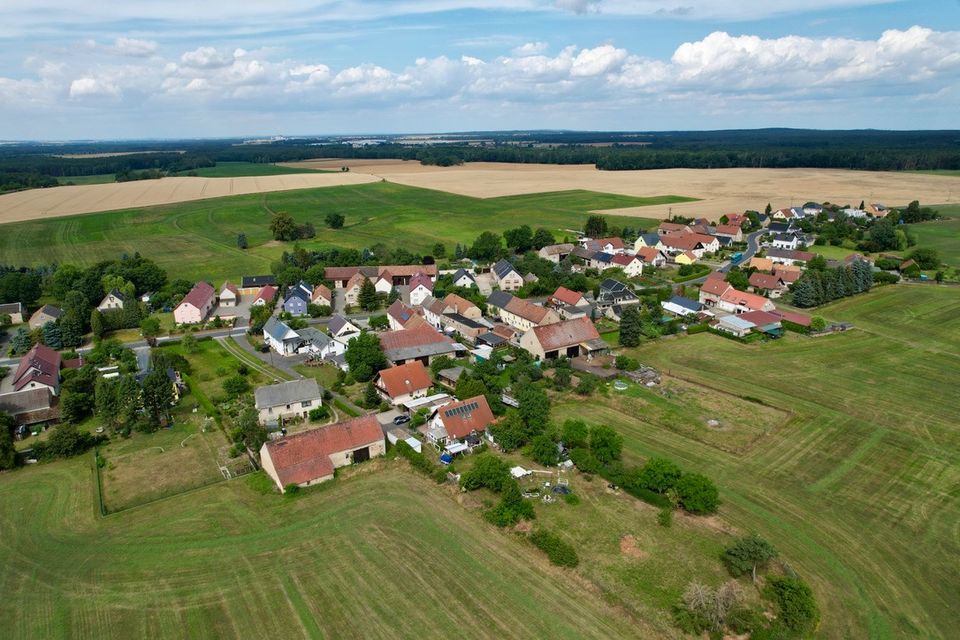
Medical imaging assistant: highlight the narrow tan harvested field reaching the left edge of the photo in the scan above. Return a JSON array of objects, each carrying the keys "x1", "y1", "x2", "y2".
[{"x1": 0, "y1": 171, "x2": 377, "y2": 223}]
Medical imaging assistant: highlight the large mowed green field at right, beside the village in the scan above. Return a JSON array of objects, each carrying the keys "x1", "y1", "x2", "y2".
[{"x1": 557, "y1": 285, "x2": 960, "y2": 638}]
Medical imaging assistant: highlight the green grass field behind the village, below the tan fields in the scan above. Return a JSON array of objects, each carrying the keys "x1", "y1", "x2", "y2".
[{"x1": 0, "y1": 183, "x2": 685, "y2": 282}]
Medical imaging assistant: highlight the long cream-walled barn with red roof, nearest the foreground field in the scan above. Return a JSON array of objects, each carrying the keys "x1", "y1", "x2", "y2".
[{"x1": 260, "y1": 415, "x2": 387, "y2": 491}]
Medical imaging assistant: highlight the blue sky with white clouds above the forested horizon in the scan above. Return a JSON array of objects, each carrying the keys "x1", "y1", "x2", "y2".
[{"x1": 0, "y1": 0, "x2": 960, "y2": 140}]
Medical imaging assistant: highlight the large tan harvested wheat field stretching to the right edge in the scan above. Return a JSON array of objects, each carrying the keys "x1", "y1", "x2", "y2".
[{"x1": 289, "y1": 160, "x2": 960, "y2": 218}]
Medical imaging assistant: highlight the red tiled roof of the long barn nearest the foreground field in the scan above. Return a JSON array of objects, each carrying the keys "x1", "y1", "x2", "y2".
[{"x1": 264, "y1": 414, "x2": 383, "y2": 486}]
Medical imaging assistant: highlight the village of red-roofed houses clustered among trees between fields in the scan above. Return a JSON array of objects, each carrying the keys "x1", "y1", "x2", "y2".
[{"x1": 0, "y1": 202, "x2": 909, "y2": 492}]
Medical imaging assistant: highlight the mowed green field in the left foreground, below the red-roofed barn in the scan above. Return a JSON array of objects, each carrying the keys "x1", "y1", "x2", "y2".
[{"x1": 0, "y1": 456, "x2": 648, "y2": 640}]
